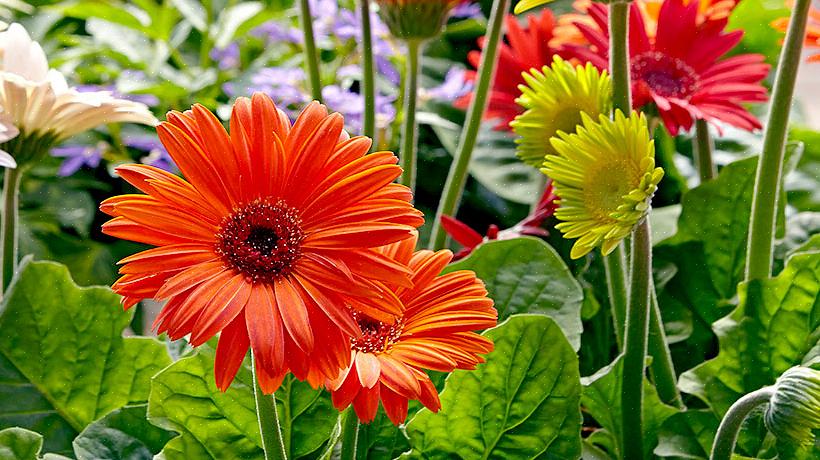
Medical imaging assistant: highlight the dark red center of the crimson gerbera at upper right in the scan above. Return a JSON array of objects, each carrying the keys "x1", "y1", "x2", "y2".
[{"x1": 632, "y1": 51, "x2": 698, "y2": 99}]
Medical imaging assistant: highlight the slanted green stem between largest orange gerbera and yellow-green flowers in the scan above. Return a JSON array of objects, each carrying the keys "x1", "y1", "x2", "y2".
[{"x1": 429, "y1": 0, "x2": 510, "y2": 249}]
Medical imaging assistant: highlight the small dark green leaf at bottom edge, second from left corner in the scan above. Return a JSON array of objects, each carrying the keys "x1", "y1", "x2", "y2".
[{"x1": 73, "y1": 404, "x2": 174, "y2": 460}]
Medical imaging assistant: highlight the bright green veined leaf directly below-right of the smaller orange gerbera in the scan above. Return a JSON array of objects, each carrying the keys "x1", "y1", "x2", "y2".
[{"x1": 406, "y1": 315, "x2": 581, "y2": 459}]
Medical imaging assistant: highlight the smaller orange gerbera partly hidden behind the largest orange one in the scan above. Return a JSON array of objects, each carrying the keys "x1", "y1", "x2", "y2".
[{"x1": 327, "y1": 232, "x2": 498, "y2": 425}]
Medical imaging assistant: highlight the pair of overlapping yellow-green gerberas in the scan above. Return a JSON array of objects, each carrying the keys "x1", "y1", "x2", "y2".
[{"x1": 510, "y1": 57, "x2": 663, "y2": 258}]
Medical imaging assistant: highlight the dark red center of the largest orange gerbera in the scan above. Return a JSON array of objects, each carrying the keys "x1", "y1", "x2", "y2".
[{"x1": 216, "y1": 199, "x2": 305, "y2": 282}]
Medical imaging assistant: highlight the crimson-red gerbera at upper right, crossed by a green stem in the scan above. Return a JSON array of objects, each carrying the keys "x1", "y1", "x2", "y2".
[{"x1": 568, "y1": 0, "x2": 769, "y2": 135}]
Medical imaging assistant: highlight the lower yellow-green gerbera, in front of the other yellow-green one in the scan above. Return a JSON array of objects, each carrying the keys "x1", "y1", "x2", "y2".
[{"x1": 541, "y1": 111, "x2": 663, "y2": 259}]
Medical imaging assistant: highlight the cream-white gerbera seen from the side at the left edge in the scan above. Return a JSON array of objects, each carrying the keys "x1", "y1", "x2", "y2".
[{"x1": 0, "y1": 24, "x2": 157, "y2": 167}]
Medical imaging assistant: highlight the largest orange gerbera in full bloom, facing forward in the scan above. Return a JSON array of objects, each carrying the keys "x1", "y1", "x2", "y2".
[{"x1": 100, "y1": 93, "x2": 423, "y2": 393}]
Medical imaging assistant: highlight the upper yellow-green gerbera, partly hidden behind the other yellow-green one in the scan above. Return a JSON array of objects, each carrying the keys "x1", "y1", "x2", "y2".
[{"x1": 510, "y1": 56, "x2": 612, "y2": 168}]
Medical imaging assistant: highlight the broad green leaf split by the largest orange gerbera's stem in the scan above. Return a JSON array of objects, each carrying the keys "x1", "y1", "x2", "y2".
[{"x1": 148, "y1": 346, "x2": 338, "y2": 460}]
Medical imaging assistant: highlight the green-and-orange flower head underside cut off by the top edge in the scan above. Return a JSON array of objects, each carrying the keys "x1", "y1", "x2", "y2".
[{"x1": 376, "y1": 0, "x2": 462, "y2": 40}]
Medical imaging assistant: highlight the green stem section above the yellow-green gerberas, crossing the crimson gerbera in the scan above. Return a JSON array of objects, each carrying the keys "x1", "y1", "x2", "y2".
[{"x1": 609, "y1": 1, "x2": 632, "y2": 115}]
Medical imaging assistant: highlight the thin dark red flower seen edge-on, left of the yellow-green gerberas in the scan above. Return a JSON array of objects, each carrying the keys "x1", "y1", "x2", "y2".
[{"x1": 441, "y1": 181, "x2": 558, "y2": 261}]
